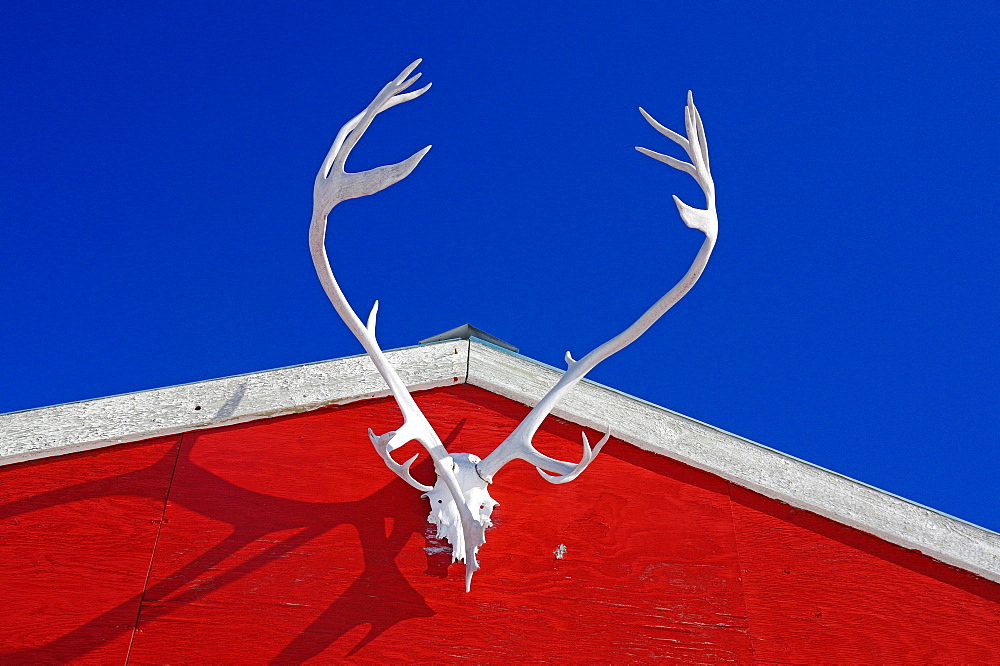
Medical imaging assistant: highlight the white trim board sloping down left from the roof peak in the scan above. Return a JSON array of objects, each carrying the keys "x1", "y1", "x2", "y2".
[{"x1": 0, "y1": 340, "x2": 469, "y2": 465}]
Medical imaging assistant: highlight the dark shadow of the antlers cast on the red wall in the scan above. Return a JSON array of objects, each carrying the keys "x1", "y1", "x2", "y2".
[{"x1": 0, "y1": 420, "x2": 464, "y2": 663}]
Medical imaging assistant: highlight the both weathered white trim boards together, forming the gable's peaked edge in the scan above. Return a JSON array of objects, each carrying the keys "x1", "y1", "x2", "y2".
[{"x1": 0, "y1": 339, "x2": 1000, "y2": 582}]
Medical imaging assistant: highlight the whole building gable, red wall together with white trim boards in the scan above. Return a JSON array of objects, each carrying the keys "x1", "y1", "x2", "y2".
[{"x1": 0, "y1": 339, "x2": 1000, "y2": 663}]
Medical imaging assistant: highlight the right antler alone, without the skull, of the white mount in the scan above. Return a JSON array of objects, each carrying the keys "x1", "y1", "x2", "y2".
[{"x1": 477, "y1": 91, "x2": 719, "y2": 483}]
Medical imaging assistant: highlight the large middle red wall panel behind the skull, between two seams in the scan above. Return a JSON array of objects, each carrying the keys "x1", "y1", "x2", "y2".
[{"x1": 132, "y1": 386, "x2": 750, "y2": 663}]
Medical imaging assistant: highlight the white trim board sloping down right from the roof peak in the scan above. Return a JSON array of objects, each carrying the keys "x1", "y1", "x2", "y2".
[{"x1": 468, "y1": 340, "x2": 1000, "y2": 582}]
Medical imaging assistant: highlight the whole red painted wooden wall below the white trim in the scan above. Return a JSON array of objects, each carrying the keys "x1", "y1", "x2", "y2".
[{"x1": 0, "y1": 386, "x2": 1000, "y2": 664}]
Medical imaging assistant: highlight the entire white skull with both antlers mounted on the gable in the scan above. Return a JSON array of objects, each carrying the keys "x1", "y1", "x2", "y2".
[{"x1": 309, "y1": 74, "x2": 718, "y2": 591}]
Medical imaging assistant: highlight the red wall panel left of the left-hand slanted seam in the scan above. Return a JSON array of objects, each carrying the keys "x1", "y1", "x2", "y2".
[{"x1": 0, "y1": 437, "x2": 179, "y2": 664}]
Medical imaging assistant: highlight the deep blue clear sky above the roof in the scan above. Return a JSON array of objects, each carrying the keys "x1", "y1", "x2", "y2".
[{"x1": 0, "y1": 2, "x2": 1000, "y2": 530}]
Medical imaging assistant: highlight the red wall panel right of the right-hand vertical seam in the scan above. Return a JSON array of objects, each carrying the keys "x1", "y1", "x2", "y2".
[{"x1": 732, "y1": 487, "x2": 1000, "y2": 664}]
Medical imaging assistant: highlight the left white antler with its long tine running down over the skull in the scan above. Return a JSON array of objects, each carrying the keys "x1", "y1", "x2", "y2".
[{"x1": 309, "y1": 60, "x2": 485, "y2": 591}]
